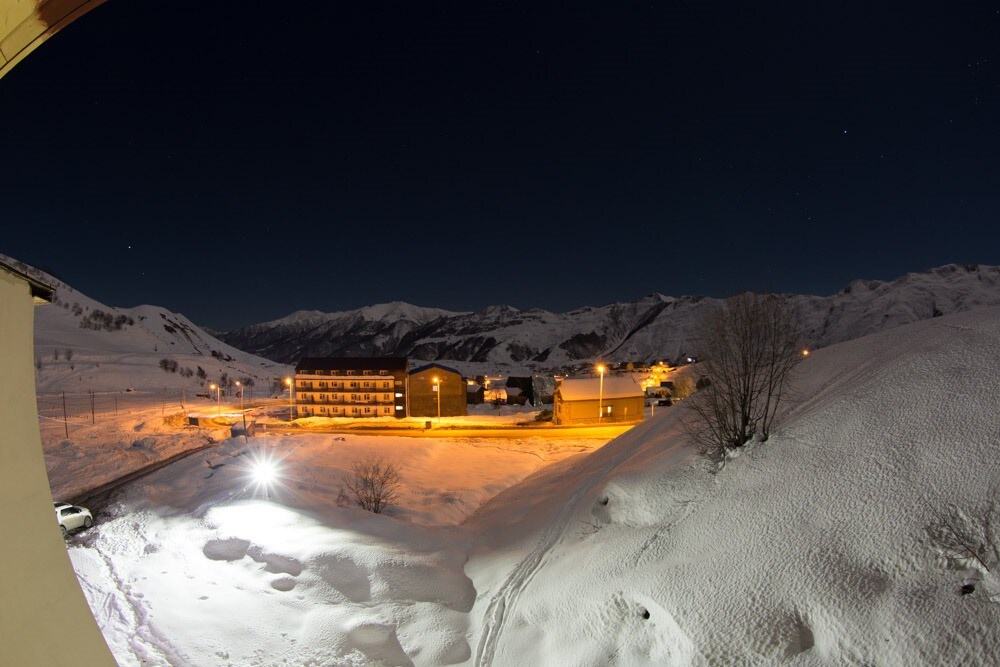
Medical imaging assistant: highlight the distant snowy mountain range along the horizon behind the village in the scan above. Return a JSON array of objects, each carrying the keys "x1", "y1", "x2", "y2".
[{"x1": 218, "y1": 264, "x2": 1000, "y2": 370}]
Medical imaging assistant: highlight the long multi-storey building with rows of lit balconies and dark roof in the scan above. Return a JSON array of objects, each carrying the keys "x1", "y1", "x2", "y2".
[{"x1": 295, "y1": 357, "x2": 407, "y2": 417}]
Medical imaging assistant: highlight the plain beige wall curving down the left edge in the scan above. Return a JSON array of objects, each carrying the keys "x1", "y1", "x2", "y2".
[{"x1": 0, "y1": 269, "x2": 115, "y2": 667}]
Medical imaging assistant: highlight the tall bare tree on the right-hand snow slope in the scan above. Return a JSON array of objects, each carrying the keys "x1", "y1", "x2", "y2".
[{"x1": 685, "y1": 292, "x2": 802, "y2": 463}]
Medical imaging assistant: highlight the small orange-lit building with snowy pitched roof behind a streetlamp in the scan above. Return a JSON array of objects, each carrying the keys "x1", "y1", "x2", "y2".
[{"x1": 553, "y1": 375, "x2": 646, "y2": 424}]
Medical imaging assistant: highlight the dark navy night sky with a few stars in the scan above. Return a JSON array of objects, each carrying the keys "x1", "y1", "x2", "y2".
[{"x1": 0, "y1": 0, "x2": 1000, "y2": 329}]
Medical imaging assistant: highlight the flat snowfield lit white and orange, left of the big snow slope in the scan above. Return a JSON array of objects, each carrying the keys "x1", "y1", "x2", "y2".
[{"x1": 70, "y1": 434, "x2": 606, "y2": 665}]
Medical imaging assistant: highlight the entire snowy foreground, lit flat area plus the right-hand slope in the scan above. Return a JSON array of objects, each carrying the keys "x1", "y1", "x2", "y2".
[{"x1": 60, "y1": 308, "x2": 1000, "y2": 665}]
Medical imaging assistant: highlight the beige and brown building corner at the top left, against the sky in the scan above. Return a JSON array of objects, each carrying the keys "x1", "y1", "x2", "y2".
[{"x1": 0, "y1": 0, "x2": 104, "y2": 77}]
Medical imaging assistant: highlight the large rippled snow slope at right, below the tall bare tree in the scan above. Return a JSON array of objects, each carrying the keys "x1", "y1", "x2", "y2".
[{"x1": 466, "y1": 309, "x2": 1000, "y2": 665}]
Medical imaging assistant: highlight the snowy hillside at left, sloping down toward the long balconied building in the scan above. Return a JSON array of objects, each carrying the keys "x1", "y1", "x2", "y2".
[{"x1": 0, "y1": 255, "x2": 290, "y2": 395}]
